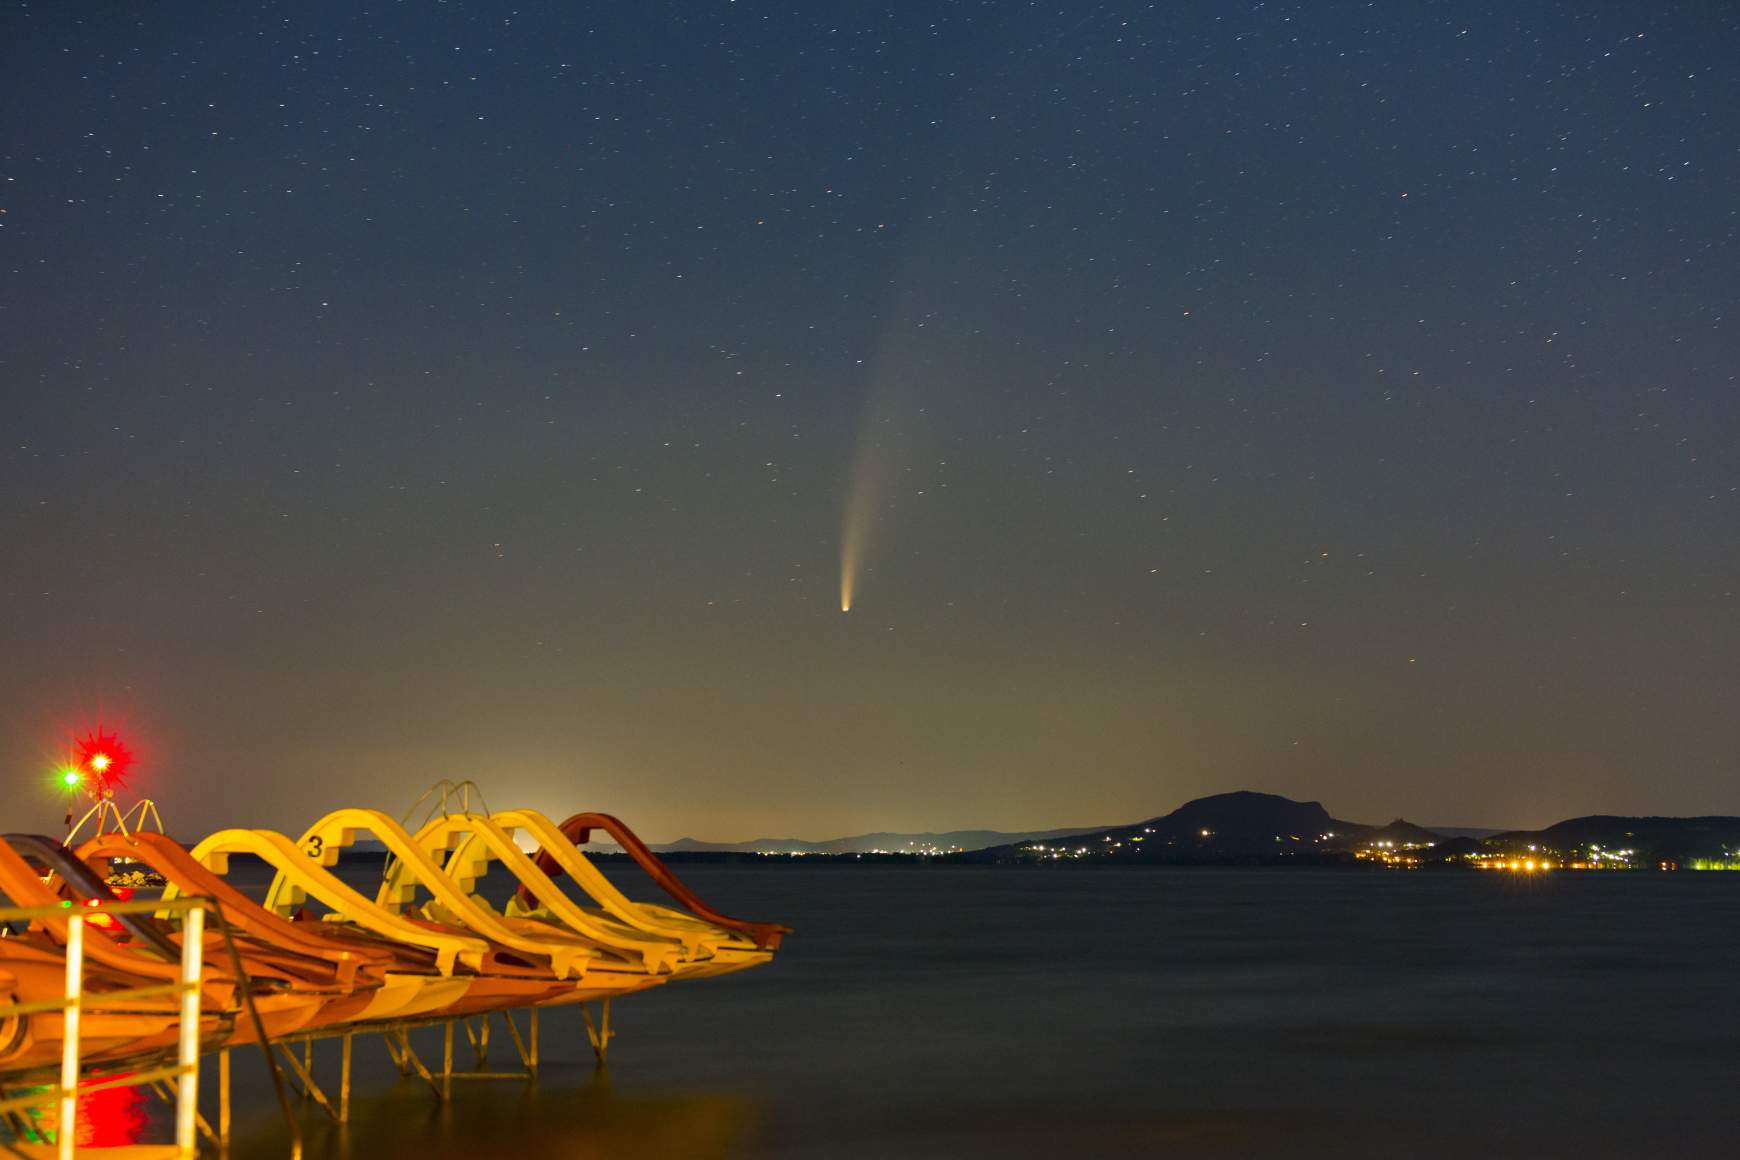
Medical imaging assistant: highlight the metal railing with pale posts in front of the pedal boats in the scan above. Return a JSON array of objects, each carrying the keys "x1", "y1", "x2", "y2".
[{"x1": 0, "y1": 896, "x2": 208, "y2": 1160}]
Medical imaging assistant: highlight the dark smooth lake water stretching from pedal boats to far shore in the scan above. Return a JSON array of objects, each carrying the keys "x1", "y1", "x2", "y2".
[{"x1": 142, "y1": 864, "x2": 1740, "y2": 1160}]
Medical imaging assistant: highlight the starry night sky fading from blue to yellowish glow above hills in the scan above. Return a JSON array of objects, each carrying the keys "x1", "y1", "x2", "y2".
[{"x1": 0, "y1": 0, "x2": 1740, "y2": 840}]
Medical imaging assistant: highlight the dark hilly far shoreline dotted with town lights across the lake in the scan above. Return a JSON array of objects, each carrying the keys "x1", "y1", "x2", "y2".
[{"x1": 599, "y1": 790, "x2": 1740, "y2": 875}]
